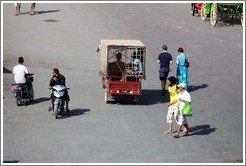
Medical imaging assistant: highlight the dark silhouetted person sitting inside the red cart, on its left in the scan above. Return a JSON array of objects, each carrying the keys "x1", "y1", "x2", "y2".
[{"x1": 108, "y1": 52, "x2": 126, "y2": 80}]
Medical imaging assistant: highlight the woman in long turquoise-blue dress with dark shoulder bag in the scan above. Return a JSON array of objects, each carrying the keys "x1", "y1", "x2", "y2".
[{"x1": 176, "y1": 47, "x2": 189, "y2": 89}]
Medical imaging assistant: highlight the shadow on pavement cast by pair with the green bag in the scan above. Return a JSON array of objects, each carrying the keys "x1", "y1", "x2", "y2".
[{"x1": 190, "y1": 124, "x2": 217, "y2": 135}]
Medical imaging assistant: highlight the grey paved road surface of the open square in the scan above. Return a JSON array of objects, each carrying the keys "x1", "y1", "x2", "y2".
[{"x1": 2, "y1": 3, "x2": 245, "y2": 164}]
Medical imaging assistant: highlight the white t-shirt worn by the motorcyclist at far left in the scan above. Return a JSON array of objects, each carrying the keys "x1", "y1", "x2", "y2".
[{"x1": 13, "y1": 64, "x2": 28, "y2": 84}]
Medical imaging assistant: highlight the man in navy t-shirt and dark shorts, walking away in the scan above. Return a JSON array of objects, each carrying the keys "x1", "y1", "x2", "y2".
[{"x1": 157, "y1": 45, "x2": 173, "y2": 96}]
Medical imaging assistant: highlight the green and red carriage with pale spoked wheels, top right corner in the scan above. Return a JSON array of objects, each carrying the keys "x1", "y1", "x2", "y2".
[{"x1": 192, "y1": 3, "x2": 243, "y2": 26}]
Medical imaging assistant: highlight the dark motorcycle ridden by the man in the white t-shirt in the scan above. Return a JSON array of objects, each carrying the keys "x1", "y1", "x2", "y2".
[{"x1": 11, "y1": 74, "x2": 34, "y2": 106}]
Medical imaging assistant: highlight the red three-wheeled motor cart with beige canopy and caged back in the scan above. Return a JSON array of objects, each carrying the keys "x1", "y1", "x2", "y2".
[{"x1": 99, "y1": 40, "x2": 146, "y2": 103}]
